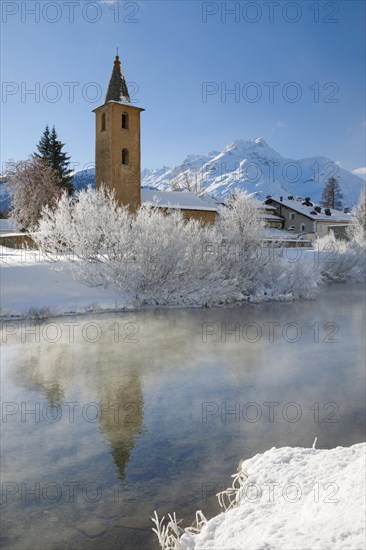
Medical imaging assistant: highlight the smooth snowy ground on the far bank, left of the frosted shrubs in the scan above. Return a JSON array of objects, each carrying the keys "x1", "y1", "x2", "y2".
[{"x1": 0, "y1": 247, "x2": 126, "y2": 318}]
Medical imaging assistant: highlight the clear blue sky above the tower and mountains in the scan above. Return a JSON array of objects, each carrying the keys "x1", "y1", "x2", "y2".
[{"x1": 1, "y1": 0, "x2": 366, "y2": 176}]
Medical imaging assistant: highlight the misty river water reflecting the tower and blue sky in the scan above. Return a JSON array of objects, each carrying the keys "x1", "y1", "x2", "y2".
[{"x1": 1, "y1": 285, "x2": 365, "y2": 550}]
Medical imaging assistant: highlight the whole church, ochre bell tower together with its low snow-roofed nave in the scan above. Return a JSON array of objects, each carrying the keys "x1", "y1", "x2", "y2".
[{"x1": 93, "y1": 55, "x2": 217, "y2": 223}]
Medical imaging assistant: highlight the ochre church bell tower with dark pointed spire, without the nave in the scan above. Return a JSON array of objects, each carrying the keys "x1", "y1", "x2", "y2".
[{"x1": 93, "y1": 55, "x2": 144, "y2": 212}]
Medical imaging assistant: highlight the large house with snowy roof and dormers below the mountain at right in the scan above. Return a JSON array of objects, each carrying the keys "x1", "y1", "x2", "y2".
[{"x1": 265, "y1": 196, "x2": 350, "y2": 241}]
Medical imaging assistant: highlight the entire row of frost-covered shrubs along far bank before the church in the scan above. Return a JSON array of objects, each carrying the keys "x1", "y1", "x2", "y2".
[{"x1": 33, "y1": 188, "x2": 320, "y2": 306}]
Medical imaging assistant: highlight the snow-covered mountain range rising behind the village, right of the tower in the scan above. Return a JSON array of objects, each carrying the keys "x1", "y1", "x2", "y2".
[{"x1": 139, "y1": 137, "x2": 364, "y2": 206}]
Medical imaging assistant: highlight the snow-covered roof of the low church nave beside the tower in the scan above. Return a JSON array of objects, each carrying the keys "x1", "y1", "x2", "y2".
[{"x1": 141, "y1": 189, "x2": 217, "y2": 212}]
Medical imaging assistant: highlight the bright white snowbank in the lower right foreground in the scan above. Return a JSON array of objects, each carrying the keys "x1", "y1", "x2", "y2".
[{"x1": 181, "y1": 443, "x2": 366, "y2": 550}]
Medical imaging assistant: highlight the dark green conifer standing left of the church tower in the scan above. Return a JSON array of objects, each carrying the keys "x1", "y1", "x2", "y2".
[{"x1": 35, "y1": 126, "x2": 74, "y2": 194}]
